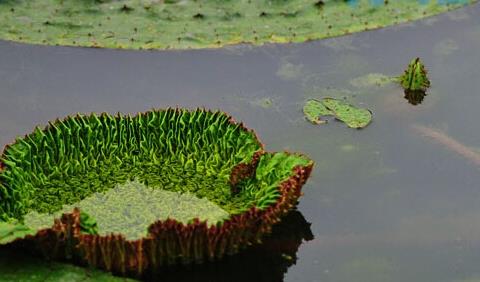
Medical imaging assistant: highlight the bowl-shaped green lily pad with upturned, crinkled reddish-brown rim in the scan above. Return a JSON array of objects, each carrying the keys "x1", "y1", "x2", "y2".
[{"x1": 0, "y1": 109, "x2": 313, "y2": 276}]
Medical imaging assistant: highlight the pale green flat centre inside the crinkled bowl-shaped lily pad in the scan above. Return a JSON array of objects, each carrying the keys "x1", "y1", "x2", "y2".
[{"x1": 24, "y1": 181, "x2": 229, "y2": 240}]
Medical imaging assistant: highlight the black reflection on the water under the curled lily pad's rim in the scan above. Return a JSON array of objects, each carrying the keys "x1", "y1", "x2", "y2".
[{"x1": 145, "y1": 211, "x2": 313, "y2": 282}]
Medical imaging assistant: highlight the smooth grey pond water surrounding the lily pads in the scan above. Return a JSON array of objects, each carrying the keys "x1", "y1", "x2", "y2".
[{"x1": 0, "y1": 4, "x2": 480, "y2": 282}]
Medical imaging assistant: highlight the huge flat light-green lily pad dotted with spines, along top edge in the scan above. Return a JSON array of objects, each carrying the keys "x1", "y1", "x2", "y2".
[{"x1": 0, "y1": 0, "x2": 476, "y2": 49}]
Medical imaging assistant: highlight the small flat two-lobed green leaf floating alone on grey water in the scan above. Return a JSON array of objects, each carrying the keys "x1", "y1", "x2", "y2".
[{"x1": 303, "y1": 98, "x2": 372, "y2": 128}]
